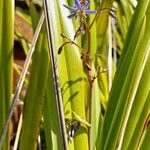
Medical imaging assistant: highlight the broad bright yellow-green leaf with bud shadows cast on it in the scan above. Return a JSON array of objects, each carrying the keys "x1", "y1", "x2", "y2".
[{"x1": 57, "y1": 1, "x2": 88, "y2": 150}]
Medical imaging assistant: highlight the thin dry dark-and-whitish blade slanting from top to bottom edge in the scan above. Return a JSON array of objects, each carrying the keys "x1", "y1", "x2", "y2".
[{"x1": 44, "y1": 0, "x2": 67, "y2": 150}]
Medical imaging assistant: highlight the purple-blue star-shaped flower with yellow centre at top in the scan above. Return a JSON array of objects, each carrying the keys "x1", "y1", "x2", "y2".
[{"x1": 63, "y1": 0, "x2": 97, "y2": 19}]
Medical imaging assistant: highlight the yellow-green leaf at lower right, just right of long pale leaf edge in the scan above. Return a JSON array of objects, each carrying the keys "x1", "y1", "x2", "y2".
[{"x1": 127, "y1": 57, "x2": 150, "y2": 149}]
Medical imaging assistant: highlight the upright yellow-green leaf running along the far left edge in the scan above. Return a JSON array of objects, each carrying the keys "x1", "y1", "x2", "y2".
[{"x1": 0, "y1": 0, "x2": 14, "y2": 149}]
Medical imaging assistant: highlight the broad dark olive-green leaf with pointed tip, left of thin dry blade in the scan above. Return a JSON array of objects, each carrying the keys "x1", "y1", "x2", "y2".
[{"x1": 20, "y1": 33, "x2": 49, "y2": 150}]
